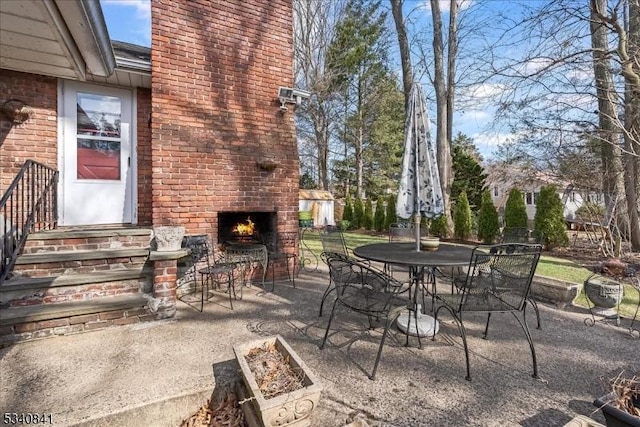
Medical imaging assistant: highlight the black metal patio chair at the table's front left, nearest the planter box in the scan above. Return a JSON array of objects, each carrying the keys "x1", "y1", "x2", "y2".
[{"x1": 320, "y1": 256, "x2": 409, "y2": 380}]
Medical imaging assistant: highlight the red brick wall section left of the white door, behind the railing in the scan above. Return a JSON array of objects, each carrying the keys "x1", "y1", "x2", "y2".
[{"x1": 0, "y1": 70, "x2": 58, "y2": 188}]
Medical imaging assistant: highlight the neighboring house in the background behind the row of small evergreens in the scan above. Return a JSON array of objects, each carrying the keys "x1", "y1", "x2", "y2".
[{"x1": 485, "y1": 164, "x2": 603, "y2": 223}]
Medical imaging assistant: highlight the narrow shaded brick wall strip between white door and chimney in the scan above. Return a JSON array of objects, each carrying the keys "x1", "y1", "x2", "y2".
[{"x1": 137, "y1": 88, "x2": 152, "y2": 225}]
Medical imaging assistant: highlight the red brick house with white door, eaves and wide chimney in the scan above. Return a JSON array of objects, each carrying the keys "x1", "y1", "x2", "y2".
[{"x1": 0, "y1": 0, "x2": 299, "y2": 342}]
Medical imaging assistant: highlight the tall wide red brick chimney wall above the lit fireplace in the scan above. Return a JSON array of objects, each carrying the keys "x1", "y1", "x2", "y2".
[{"x1": 151, "y1": 0, "x2": 299, "y2": 238}]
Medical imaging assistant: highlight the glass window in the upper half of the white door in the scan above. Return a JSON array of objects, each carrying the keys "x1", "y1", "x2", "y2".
[{"x1": 77, "y1": 92, "x2": 122, "y2": 180}]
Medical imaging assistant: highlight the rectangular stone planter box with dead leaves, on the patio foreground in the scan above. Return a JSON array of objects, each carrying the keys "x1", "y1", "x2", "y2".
[{"x1": 233, "y1": 335, "x2": 322, "y2": 427}]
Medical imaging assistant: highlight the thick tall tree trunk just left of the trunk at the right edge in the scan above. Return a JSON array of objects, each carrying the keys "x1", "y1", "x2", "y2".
[{"x1": 590, "y1": 0, "x2": 627, "y2": 254}]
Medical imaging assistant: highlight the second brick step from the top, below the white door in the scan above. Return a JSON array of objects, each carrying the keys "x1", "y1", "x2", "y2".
[{"x1": 14, "y1": 248, "x2": 149, "y2": 277}]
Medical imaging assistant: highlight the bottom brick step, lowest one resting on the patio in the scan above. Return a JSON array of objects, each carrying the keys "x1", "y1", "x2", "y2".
[{"x1": 0, "y1": 294, "x2": 155, "y2": 347}]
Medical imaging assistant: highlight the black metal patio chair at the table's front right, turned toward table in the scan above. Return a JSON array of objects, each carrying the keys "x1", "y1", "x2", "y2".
[{"x1": 433, "y1": 244, "x2": 542, "y2": 380}]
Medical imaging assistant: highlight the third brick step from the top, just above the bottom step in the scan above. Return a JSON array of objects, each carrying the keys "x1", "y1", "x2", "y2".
[{"x1": 0, "y1": 267, "x2": 153, "y2": 306}]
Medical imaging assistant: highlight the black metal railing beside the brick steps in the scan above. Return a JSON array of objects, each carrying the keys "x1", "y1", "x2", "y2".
[{"x1": 0, "y1": 160, "x2": 58, "y2": 286}]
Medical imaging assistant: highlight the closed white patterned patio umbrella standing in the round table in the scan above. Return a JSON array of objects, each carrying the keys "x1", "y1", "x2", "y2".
[{"x1": 396, "y1": 83, "x2": 444, "y2": 251}]
